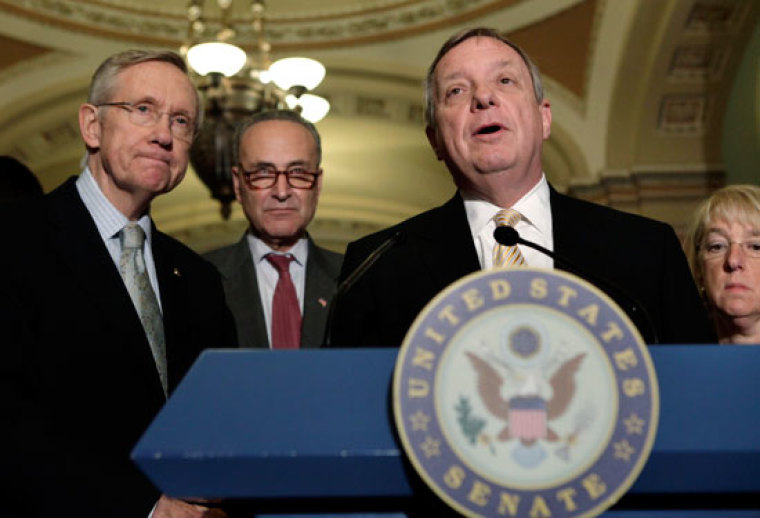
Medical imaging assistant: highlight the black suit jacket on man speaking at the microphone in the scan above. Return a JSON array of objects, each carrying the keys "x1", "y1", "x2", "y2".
[{"x1": 332, "y1": 188, "x2": 714, "y2": 347}]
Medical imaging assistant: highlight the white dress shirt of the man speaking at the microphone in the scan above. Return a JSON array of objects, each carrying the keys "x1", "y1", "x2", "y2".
[{"x1": 462, "y1": 174, "x2": 554, "y2": 270}]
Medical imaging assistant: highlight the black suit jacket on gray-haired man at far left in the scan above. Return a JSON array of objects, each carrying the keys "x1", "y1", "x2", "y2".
[{"x1": 0, "y1": 178, "x2": 236, "y2": 518}]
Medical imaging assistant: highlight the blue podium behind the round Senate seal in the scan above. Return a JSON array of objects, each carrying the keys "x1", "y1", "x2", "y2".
[{"x1": 132, "y1": 346, "x2": 760, "y2": 518}]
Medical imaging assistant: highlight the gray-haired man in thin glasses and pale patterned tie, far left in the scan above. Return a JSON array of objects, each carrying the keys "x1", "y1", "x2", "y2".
[{"x1": 0, "y1": 50, "x2": 236, "y2": 518}]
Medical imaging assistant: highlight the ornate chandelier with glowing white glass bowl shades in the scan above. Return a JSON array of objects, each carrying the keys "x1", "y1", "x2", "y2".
[{"x1": 180, "y1": 0, "x2": 330, "y2": 219}]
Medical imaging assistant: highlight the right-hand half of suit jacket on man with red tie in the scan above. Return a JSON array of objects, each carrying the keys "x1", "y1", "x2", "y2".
[{"x1": 301, "y1": 242, "x2": 340, "y2": 348}]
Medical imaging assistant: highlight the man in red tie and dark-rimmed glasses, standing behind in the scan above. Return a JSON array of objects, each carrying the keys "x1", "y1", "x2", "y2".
[{"x1": 206, "y1": 110, "x2": 342, "y2": 349}]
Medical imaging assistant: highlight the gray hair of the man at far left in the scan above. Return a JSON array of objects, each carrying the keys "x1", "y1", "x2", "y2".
[{"x1": 87, "y1": 49, "x2": 203, "y2": 132}]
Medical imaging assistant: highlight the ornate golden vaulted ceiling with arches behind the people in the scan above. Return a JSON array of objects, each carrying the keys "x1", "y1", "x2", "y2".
[{"x1": 0, "y1": 0, "x2": 760, "y2": 250}]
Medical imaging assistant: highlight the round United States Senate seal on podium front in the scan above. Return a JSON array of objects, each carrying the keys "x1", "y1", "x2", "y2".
[{"x1": 393, "y1": 268, "x2": 659, "y2": 518}]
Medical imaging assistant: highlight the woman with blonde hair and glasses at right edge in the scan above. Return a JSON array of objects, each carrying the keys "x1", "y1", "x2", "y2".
[{"x1": 684, "y1": 185, "x2": 760, "y2": 344}]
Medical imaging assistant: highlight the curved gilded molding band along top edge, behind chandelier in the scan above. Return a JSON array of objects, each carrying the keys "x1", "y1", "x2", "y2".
[{"x1": 0, "y1": 0, "x2": 525, "y2": 51}]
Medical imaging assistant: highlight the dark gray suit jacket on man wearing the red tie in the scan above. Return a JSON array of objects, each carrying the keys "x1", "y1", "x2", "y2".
[{"x1": 204, "y1": 235, "x2": 343, "y2": 348}]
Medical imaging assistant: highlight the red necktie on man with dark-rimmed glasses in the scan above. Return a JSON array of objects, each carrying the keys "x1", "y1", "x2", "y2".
[{"x1": 266, "y1": 254, "x2": 301, "y2": 349}]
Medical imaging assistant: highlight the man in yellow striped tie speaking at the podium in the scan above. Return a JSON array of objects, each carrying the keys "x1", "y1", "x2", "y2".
[{"x1": 331, "y1": 28, "x2": 714, "y2": 347}]
